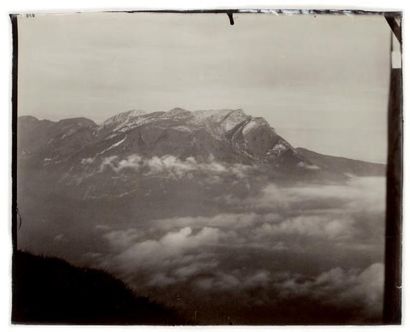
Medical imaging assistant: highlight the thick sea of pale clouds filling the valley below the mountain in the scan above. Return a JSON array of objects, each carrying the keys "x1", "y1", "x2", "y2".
[{"x1": 81, "y1": 175, "x2": 385, "y2": 321}]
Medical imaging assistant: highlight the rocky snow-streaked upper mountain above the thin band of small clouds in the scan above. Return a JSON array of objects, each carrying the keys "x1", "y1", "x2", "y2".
[{"x1": 18, "y1": 108, "x2": 384, "y2": 177}]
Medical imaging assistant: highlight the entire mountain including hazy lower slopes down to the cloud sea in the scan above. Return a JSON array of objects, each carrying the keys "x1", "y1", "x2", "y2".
[{"x1": 17, "y1": 108, "x2": 385, "y2": 259}]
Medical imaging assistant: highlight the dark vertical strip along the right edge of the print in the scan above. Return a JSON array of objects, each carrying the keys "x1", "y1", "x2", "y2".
[{"x1": 383, "y1": 12, "x2": 403, "y2": 325}]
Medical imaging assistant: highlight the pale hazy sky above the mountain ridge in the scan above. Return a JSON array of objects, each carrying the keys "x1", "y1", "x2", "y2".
[{"x1": 18, "y1": 13, "x2": 390, "y2": 162}]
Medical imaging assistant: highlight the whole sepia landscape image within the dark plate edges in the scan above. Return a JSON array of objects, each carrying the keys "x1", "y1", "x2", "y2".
[{"x1": 12, "y1": 12, "x2": 401, "y2": 325}]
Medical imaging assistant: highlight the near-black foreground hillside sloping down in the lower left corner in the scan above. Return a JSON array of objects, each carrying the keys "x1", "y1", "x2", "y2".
[{"x1": 12, "y1": 251, "x2": 188, "y2": 325}]
